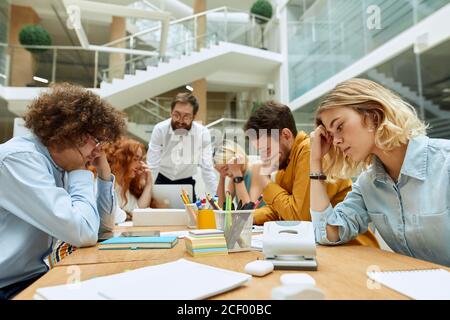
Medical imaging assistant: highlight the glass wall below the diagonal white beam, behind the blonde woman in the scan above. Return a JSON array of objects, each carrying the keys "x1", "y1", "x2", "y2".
[{"x1": 288, "y1": 41, "x2": 450, "y2": 139}]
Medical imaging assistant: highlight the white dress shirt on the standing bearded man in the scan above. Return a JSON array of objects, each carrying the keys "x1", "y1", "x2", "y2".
[{"x1": 147, "y1": 118, "x2": 217, "y2": 194}]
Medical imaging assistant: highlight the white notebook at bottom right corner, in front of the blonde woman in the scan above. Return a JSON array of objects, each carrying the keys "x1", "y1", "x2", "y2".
[{"x1": 367, "y1": 269, "x2": 450, "y2": 300}]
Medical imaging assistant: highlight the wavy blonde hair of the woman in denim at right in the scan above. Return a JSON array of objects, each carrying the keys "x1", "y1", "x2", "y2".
[{"x1": 316, "y1": 79, "x2": 427, "y2": 179}]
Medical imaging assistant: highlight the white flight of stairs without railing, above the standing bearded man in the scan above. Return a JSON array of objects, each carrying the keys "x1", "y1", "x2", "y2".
[{"x1": 98, "y1": 42, "x2": 282, "y2": 110}]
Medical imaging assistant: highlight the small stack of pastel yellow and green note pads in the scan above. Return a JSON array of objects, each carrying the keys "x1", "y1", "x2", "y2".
[{"x1": 184, "y1": 229, "x2": 228, "y2": 257}]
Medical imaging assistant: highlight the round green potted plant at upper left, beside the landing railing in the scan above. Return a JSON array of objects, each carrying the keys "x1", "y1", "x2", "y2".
[{"x1": 19, "y1": 25, "x2": 52, "y2": 85}]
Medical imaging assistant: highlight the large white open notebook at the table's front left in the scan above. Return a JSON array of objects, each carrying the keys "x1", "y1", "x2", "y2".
[{"x1": 34, "y1": 259, "x2": 251, "y2": 300}]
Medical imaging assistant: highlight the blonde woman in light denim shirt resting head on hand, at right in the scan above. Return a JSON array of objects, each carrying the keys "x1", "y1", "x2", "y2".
[{"x1": 310, "y1": 79, "x2": 450, "y2": 266}]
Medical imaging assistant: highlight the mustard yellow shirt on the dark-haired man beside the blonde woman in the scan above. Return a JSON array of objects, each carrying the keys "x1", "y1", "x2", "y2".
[{"x1": 254, "y1": 132, "x2": 379, "y2": 247}]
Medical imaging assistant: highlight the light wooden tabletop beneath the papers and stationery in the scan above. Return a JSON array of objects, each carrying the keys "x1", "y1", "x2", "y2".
[{"x1": 15, "y1": 228, "x2": 450, "y2": 300}]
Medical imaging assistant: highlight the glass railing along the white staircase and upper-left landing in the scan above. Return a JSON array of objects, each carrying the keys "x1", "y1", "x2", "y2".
[{"x1": 0, "y1": 7, "x2": 278, "y2": 88}]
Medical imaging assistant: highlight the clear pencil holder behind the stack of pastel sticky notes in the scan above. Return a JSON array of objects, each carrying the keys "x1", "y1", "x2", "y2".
[{"x1": 214, "y1": 210, "x2": 254, "y2": 252}]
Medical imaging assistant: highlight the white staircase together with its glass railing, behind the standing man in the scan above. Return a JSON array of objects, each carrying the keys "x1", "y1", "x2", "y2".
[{"x1": 2, "y1": 7, "x2": 283, "y2": 116}]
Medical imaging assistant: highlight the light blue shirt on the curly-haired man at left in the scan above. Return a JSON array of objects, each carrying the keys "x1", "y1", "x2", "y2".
[{"x1": 0, "y1": 135, "x2": 115, "y2": 288}]
